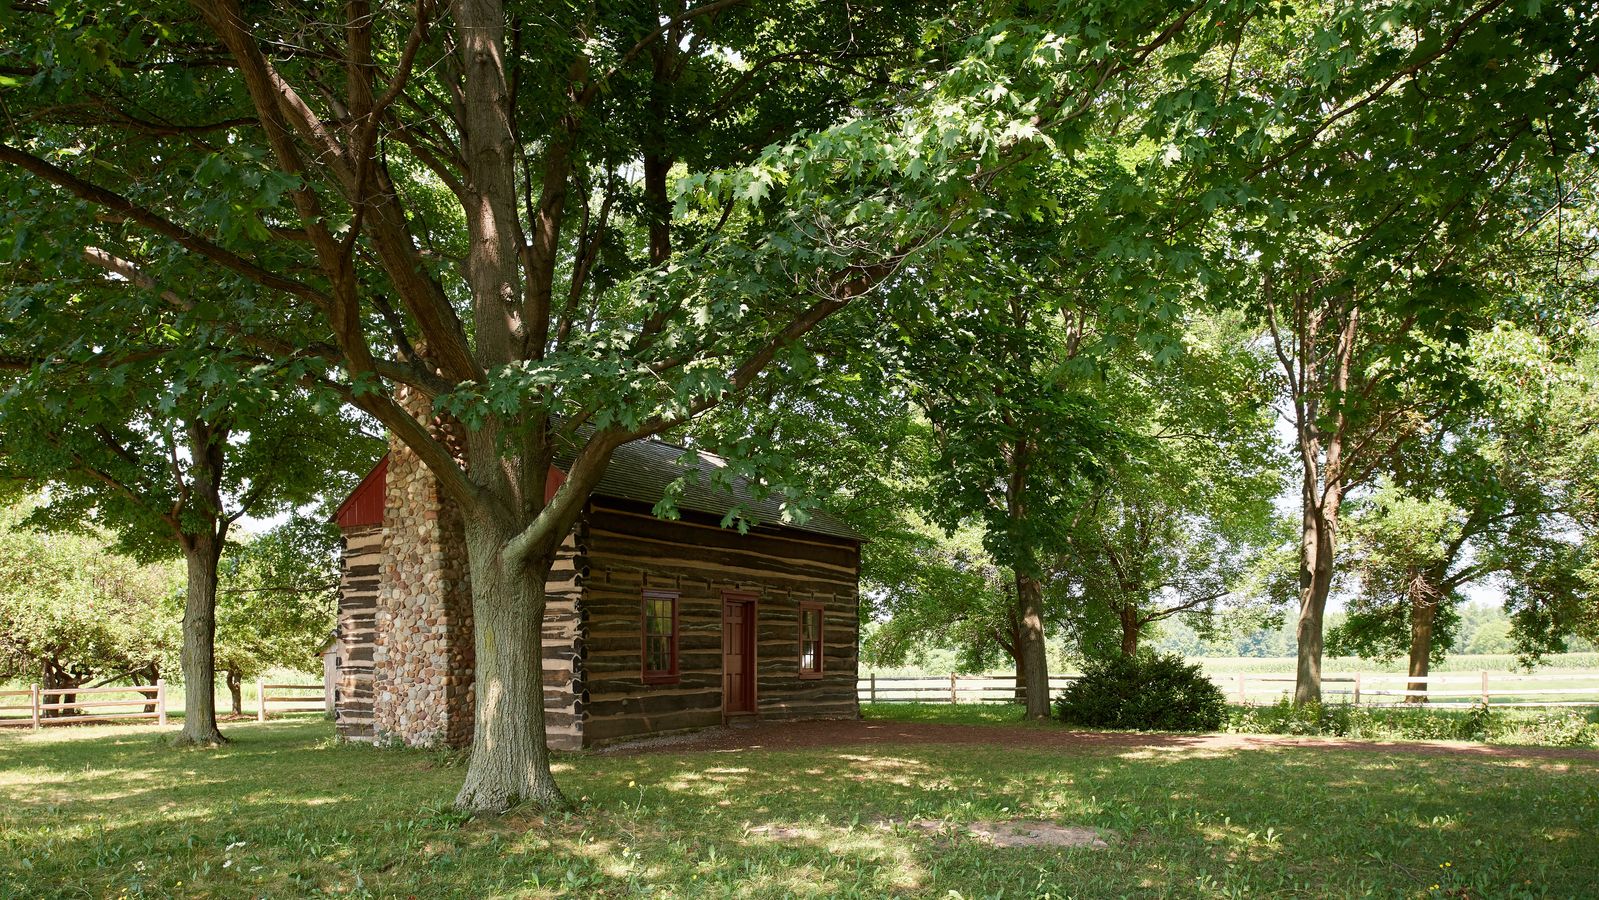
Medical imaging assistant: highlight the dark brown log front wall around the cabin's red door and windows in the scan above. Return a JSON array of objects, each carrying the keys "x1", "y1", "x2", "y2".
[{"x1": 582, "y1": 497, "x2": 860, "y2": 747}]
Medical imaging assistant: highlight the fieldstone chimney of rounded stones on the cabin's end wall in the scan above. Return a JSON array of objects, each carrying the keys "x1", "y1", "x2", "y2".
[{"x1": 373, "y1": 394, "x2": 473, "y2": 747}]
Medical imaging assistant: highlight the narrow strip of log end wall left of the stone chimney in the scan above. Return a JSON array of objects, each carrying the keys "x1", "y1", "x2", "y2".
[{"x1": 334, "y1": 524, "x2": 384, "y2": 740}]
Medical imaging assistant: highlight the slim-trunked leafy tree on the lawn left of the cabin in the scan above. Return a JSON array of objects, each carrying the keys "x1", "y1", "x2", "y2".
[{"x1": 0, "y1": 330, "x2": 377, "y2": 745}]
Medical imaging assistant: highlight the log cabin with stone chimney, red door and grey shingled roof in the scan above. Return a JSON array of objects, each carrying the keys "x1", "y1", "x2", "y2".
[{"x1": 334, "y1": 441, "x2": 860, "y2": 750}]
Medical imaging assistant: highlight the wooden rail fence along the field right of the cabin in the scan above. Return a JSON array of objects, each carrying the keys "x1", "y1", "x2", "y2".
[{"x1": 855, "y1": 671, "x2": 1599, "y2": 708}]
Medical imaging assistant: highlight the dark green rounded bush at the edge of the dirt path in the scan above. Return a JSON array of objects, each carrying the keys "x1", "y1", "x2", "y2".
[{"x1": 1057, "y1": 655, "x2": 1226, "y2": 731}]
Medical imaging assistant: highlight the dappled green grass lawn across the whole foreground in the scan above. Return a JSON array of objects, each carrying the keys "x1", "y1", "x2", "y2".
[{"x1": 0, "y1": 713, "x2": 1599, "y2": 898}]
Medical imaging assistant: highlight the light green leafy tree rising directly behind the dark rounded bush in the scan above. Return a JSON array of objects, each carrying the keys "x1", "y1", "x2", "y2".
[{"x1": 1051, "y1": 313, "x2": 1281, "y2": 657}]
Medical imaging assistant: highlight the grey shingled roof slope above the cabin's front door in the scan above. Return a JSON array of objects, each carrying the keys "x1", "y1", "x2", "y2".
[{"x1": 555, "y1": 440, "x2": 860, "y2": 540}]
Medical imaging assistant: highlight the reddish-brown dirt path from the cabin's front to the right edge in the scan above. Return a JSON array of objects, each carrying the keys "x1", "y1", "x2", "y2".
[{"x1": 604, "y1": 719, "x2": 1599, "y2": 763}]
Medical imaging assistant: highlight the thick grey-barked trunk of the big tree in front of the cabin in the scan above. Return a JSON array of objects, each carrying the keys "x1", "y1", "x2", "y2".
[{"x1": 456, "y1": 515, "x2": 566, "y2": 812}]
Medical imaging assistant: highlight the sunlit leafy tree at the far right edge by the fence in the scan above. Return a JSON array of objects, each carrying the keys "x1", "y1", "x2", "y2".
[{"x1": 1334, "y1": 321, "x2": 1599, "y2": 702}]
